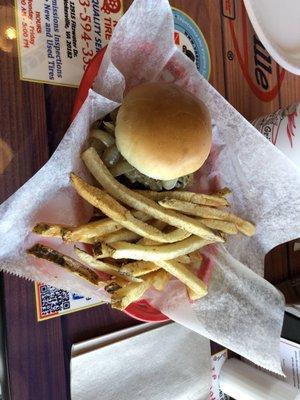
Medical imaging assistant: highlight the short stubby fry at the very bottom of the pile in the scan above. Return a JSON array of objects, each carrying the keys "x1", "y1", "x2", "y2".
[{"x1": 111, "y1": 270, "x2": 166, "y2": 310}]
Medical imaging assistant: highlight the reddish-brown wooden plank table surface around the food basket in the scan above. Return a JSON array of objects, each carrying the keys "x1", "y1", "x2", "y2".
[{"x1": 0, "y1": 0, "x2": 300, "y2": 400}]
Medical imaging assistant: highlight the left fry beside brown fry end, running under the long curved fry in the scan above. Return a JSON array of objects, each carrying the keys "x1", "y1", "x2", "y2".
[{"x1": 64, "y1": 211, "x2": 151, "y2": 243}]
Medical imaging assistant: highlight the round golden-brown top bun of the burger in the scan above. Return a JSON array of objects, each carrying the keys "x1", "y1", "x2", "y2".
[{"x1": 115, "y1": 83, "x2": 211, "y2": 180}]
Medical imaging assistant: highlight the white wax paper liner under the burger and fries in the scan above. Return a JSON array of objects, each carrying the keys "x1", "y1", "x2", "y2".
[{"x1": 0, "y1": 0, "x2": 300, "y2": 373}]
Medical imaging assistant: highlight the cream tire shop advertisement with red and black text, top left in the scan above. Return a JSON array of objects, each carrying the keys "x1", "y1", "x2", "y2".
[{"x1": 16, "y1": 0, "x2": 123, "y2": 86}]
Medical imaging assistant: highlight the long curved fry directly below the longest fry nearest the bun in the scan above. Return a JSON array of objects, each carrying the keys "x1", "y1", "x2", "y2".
[{"x1": 71, "y1": 173, "x2": 192, "y2": 243}]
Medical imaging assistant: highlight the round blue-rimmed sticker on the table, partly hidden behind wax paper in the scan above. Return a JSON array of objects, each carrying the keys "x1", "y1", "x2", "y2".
[{"x1": 172, "y1": 8, "x2": 210, "y2": 80}]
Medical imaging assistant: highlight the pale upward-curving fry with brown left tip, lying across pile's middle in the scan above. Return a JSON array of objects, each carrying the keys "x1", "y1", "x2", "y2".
[{"x1": 94, "y1": 236, "x2": 212, "y2": 261}]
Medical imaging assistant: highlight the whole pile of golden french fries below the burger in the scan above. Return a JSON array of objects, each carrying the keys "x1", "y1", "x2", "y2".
[{"x1": 28, "y1": 123, "x2": 255, "y2": 310}]
